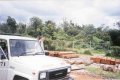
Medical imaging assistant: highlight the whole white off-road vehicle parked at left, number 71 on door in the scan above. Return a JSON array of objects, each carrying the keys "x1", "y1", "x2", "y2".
[{"x1": 0, "y1": 35, "x2": 73, "y2": 80}]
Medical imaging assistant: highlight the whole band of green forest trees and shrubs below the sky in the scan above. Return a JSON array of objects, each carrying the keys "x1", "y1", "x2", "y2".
[{"x1": 0, "y1": 16, "x2": 120, "y2": 57}]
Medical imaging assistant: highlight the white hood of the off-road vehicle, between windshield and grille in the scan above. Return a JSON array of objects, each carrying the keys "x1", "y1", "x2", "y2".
[{"x1": 11, "y1": 55, "x2": 70, "y2": 70}]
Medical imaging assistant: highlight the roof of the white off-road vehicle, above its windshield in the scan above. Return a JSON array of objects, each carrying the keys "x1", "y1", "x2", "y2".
[{"x1": 0, "y1": 35, "x2": 37, "y2": 40}]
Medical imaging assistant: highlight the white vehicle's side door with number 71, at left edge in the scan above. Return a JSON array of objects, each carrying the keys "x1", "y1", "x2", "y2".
[{"x1": 0, "y1": 40, "x2": 8, "y2": 80}]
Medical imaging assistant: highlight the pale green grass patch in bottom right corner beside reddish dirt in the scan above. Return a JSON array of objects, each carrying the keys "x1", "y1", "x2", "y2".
[{"x1": 86, "y1": 67, "x2": 120, "y2": 79}]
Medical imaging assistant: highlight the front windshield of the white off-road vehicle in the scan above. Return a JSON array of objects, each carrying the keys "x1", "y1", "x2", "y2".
[{"x1": 10, "y1": 39, "x2": 44, "y2": 56}]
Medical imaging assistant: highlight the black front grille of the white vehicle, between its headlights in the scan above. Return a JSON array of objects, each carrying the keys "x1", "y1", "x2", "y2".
[{"x1": 48, "y1": 69, "x2": 67, "y2": 80}]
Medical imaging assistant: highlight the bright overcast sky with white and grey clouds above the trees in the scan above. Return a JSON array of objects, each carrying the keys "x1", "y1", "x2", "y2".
[{"x1": 0, "y1": 0, "x2": 120, "y2": 26}]
